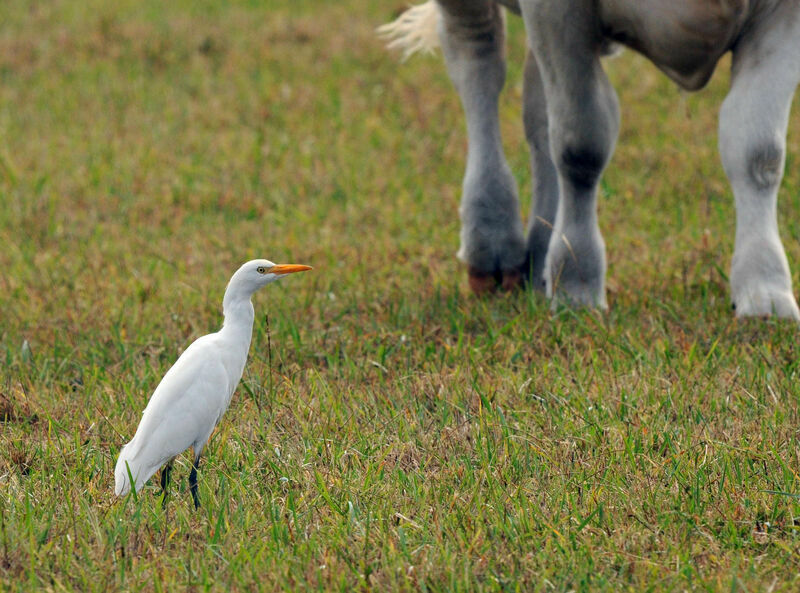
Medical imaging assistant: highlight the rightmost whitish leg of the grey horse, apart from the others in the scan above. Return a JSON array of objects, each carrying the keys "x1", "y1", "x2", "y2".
[{"x1": 719, "y1": 2, "x2": 800, "y2": 319}]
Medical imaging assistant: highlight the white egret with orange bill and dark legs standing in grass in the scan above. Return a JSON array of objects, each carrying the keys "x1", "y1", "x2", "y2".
[{"x1": 114, "y1": 259, "x2": 311, "y2": 508}]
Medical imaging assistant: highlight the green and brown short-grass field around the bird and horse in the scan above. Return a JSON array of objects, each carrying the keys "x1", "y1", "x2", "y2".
[{"x1": 0, "y1": 0, "x2": 800, "y2": 591}]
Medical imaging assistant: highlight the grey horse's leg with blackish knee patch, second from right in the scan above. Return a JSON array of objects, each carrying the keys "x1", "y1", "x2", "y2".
[{"x1": 520, "y1": 0, "x2": 619, "y2": 308}]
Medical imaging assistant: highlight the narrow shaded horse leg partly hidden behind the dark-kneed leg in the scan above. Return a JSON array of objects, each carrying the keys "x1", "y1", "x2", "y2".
[{"x1": 522, "y1": 49, "x2": 558, "y2": 290}]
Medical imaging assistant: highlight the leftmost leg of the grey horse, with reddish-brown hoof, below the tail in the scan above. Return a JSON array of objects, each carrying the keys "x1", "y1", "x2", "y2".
[{"x1": 438, "y1": 0, "x2": 525, "y2": 292}]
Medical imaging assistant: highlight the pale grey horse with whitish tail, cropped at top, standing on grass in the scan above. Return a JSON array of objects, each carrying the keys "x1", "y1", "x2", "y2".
[{"x1": 379, "y1": 0, "x2": 800, "y2": 319}]
